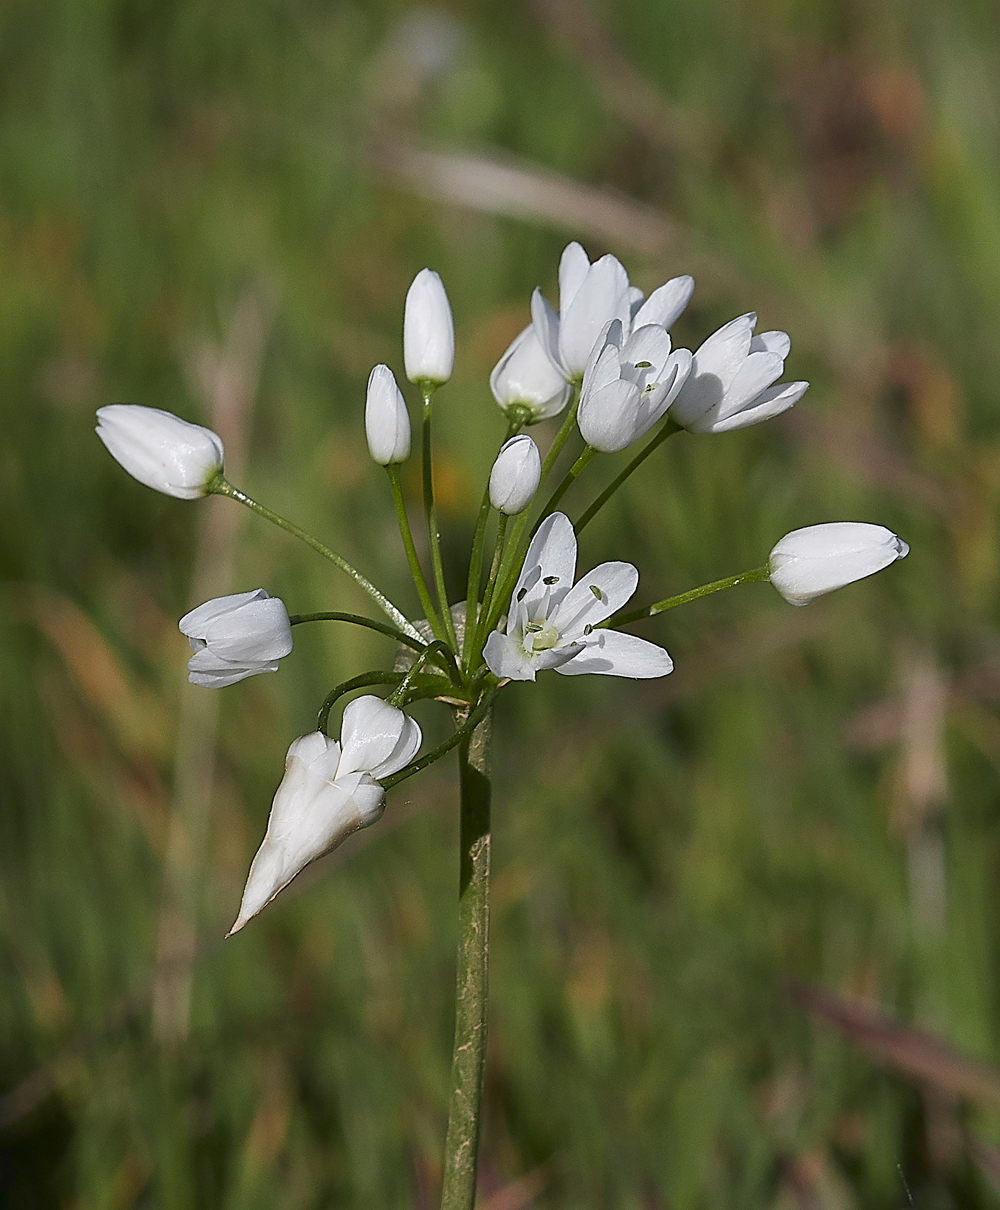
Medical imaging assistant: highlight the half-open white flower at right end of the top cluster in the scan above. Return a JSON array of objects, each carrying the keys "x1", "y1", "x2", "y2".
[{"x1": 671, "y1": 311, "x2": 809, "y2": 433}]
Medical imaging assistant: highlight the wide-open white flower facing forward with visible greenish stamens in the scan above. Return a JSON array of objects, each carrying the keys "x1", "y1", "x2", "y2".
[{"x1": 483, "y1": 513, "x2": 673, "y2": 680}]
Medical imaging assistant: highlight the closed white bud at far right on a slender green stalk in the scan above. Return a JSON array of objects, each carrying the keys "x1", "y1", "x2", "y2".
[{"x1": 770, "y1": 522, "x2": 909, "y2": 605}]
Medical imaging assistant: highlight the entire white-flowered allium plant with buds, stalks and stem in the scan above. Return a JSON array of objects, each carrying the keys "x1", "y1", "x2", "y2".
[{"x1": 97, "y1": 243, "x2": 907, "y2": 1210}]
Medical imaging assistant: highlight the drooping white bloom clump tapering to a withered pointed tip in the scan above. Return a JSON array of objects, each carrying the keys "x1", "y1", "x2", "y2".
[{"x1": 230, "y1": 695, "x2": 421, "y2": 935}]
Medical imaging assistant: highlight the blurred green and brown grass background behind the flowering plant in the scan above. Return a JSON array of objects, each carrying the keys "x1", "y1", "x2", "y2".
[{"x1": 0, "y1": 0, "x2": 1000, "y2": 1210}]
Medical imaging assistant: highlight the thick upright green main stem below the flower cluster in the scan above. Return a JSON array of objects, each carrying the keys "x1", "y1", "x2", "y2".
[{"x1": 441, "y1": 710, "x2": 493, "y2": 1210}]
